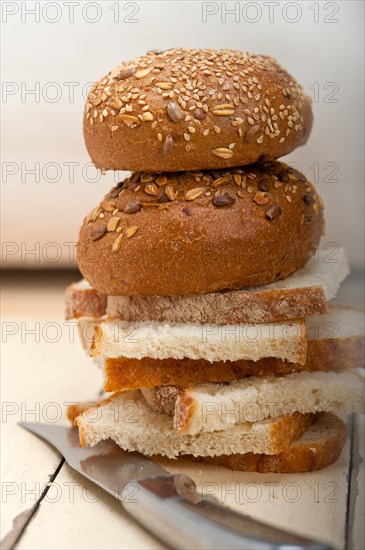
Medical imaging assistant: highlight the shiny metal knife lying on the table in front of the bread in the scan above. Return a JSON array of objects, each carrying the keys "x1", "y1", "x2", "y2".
[{"x1": 20, "y1": 422, "x2": 332, "y2": 550}]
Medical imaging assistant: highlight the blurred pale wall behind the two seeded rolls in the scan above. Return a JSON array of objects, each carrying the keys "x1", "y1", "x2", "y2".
[{"x1": 1, "y1": 0, "x2": 364, "y2": 270}]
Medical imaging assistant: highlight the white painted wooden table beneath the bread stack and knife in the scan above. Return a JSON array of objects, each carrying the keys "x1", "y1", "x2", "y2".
[{"x1": 1, "y1": 275, "x2": 365, "y2": 550}]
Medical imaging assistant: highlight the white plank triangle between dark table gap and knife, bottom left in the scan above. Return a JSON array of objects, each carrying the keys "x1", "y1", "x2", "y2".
[{"x1": 17, "y1": 465, "x2": 164, "y2": 550}]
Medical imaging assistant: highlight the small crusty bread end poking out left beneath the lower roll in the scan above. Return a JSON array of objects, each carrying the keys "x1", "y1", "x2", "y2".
[{"x1": 65, "y1": 279, "x2": 107, "y2": 319}]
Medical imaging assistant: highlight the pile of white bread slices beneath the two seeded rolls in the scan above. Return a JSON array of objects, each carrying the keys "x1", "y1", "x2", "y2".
[{"x1": 66, "y1": 246, "x2": 364, "y2": 472}]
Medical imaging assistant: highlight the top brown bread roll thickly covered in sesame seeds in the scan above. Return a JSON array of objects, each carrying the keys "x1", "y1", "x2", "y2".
[{"x1": 84, "y1": 49, "x2": 312, "y2": 172}]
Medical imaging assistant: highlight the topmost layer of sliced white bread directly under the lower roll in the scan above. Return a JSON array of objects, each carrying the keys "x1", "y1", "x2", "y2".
[{"x1": 66, "y1": 248, "x2": 349, "y2": 324}]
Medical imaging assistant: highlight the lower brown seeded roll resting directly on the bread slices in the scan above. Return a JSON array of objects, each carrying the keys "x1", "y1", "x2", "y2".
[{"x1": 78, "y1": 161, "x2": 323, "y2": 296}]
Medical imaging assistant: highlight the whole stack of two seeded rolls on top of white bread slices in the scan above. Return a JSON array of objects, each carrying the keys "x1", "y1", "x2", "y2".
[{"x1": 66, "y1": 50, "x2": 364, "y2": 473}]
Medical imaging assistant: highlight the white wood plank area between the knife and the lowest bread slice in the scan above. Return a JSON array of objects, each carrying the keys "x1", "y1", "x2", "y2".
[{"x1": 159, "y1": 444, "x2": 349, "y2": 549}]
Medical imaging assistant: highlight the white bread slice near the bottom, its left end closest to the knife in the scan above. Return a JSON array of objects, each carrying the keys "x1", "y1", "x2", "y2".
[{"x1": 75, "y1": 391, "x2": 314, "y2": 458}]
